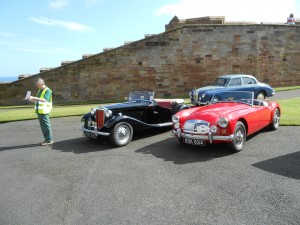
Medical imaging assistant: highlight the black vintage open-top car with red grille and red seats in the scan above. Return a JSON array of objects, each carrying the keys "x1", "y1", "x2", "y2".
[{"x1": 81, "y1": 91, "x2": 188, "y2": 146}]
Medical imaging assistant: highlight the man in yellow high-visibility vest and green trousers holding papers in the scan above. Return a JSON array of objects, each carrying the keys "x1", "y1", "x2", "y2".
[{"x1": 28, "y1": 78, "x2": 53, "y2": 146}]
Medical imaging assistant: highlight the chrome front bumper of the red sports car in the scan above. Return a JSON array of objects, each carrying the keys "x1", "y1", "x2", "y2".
[{"x1": 172, "y1": 129, "x2": 234, "y2": 144}]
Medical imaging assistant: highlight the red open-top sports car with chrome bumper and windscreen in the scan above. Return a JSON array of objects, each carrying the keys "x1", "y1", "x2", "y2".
[{"x1": 172, "y1": 91, "x2": 281, "y2": 152}]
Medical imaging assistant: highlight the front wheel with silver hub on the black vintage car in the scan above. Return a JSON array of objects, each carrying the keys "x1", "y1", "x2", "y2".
[{"x1": 110, "y1": 122, "x2": 133, "y2": 147}]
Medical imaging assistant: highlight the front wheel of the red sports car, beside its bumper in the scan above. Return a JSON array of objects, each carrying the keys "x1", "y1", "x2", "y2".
[{"x1": 229, "y1": 121, "x2": 246, "y2": 152}]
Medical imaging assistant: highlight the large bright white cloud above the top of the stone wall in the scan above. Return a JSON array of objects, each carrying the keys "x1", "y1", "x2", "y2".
[{"x1": 155, "y1": 0, "x2": 296, "y2": 23}]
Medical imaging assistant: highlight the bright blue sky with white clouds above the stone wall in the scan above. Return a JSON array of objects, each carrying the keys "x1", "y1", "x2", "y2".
[{"x1": 0, "y1": 0, "x2": 300, "y2": 81}]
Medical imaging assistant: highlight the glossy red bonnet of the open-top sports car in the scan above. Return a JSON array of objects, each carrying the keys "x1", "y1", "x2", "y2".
[{"x1": 185, "y1": 103, "x2": 250, "y2": 123}]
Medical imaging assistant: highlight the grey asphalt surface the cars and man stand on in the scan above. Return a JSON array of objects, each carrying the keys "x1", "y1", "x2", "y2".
[{"x1": 0, "y1": 90, "x2": 300, "y2": 225}]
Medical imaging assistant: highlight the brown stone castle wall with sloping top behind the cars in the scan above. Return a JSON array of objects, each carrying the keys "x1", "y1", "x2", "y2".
[{"x1": 0, "y1": 24, "x2": 300, "y2": 105}]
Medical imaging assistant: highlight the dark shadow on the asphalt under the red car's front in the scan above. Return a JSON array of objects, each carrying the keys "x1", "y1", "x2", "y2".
[{"x1": 135, "y1": 137, "x2": 232, "y2": 164}]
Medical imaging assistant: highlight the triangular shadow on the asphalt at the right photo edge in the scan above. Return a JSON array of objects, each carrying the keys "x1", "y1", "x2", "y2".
[{"x1": 253, "y1": 152, "x2": 300, "y2": 180}]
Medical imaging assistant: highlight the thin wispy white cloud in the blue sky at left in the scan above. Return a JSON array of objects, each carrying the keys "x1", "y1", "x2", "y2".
[{"x1": 30, "y1": 17, "x2": 94, "y2": 33}]
